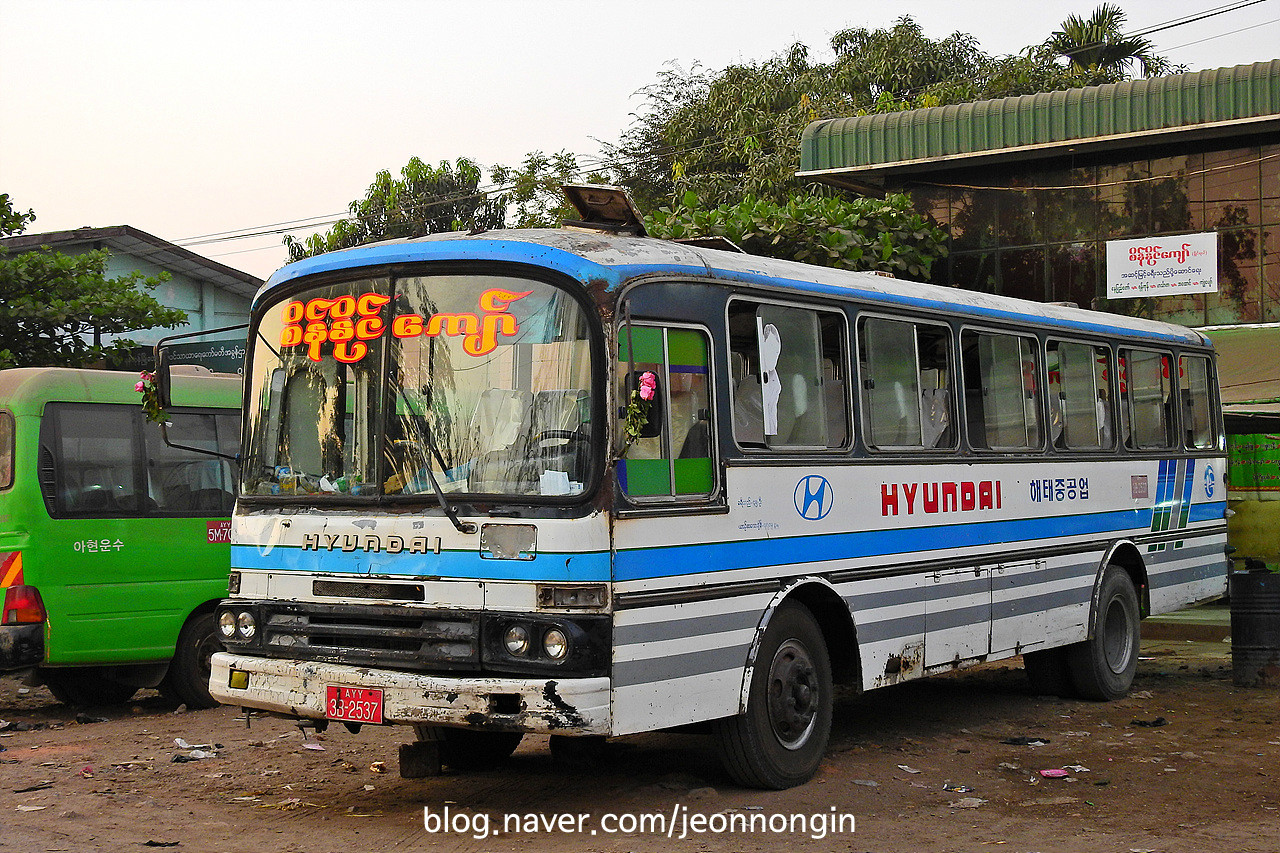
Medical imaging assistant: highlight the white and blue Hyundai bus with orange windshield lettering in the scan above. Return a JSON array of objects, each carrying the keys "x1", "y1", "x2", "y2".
[{"x1": 210, "y1": 197, "x2": 1228, "y2": 788}]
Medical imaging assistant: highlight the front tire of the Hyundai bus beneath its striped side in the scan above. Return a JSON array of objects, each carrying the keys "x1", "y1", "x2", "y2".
[{"x1": 714, "y1": 602, "x2": 832, "y2": 790}]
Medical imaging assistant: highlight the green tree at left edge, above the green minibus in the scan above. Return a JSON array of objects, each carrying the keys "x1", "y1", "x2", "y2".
[{"x1": 0, "y1": 193, "x2": 187, "y2": 368}]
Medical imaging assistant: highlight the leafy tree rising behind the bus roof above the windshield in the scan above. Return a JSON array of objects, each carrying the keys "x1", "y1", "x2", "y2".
[{"x1": 284, "y1": 158, "x2": 506, "y2": 260}]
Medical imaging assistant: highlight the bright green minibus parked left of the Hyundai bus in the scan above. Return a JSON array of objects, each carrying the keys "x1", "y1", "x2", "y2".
[{"x1": 0, "y1": 368, "x2": 241, "y2": 707}]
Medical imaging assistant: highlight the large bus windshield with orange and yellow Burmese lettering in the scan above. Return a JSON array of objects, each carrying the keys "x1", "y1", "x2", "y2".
[{"x1": 243, "y1": 275, "x2": 593, "y2": 500}]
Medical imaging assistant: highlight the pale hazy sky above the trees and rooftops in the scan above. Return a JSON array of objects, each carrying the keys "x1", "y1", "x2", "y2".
[{"x1": 0, "y1": 0, "x2": 1280, "y2": 278}]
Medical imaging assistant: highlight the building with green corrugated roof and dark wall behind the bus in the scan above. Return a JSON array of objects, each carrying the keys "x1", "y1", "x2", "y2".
[{"x1": 799, "y1": 60, "x2": 1280, "y2": 327}]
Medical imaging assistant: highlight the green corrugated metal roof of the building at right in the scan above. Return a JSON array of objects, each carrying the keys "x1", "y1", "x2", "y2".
[{"x1": 797, "y1": 59, "x2": 1280, "y2": 189}]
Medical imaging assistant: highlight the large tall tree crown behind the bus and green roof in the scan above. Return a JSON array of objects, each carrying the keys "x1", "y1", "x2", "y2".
[{"x1": 605, "y1": 17, "x2": 1169, "y2": 210}]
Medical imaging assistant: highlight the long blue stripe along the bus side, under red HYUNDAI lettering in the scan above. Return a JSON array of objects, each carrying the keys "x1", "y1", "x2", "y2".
[{"x1": 613, "y1": 502, "x2": 1224, "y2": 580}]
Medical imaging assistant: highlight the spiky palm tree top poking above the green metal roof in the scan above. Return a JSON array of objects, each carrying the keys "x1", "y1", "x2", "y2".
[{"x1": 1043, "y1": 3, "x2": 1175, "y2": 86}]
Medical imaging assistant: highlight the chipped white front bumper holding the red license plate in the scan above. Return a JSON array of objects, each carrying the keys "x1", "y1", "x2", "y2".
[{"x1": 209, "y1": 652, "x2": 611, "y2": 735}]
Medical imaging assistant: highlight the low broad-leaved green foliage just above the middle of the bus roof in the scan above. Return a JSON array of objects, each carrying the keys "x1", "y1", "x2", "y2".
[{"x1": 645, "y1": 192, "x2": 947, "y2": 279}]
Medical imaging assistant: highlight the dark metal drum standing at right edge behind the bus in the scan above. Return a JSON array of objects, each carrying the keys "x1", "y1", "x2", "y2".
[{"x1": 1228, "y1": 571, "x2": 1280, "y2": 686}]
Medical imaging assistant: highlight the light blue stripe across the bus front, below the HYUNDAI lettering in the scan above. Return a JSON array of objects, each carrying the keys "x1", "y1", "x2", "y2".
[{"x1": 232, "y1": 546, "x2": 609, "y2": 581}]
